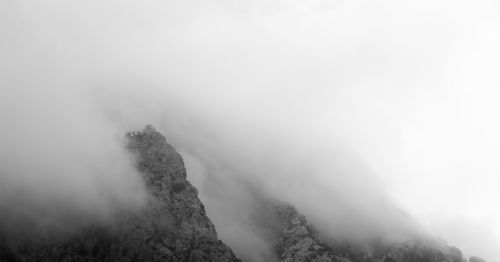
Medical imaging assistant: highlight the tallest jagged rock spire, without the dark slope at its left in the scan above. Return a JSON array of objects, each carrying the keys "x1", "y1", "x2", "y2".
[{"x1": 127, "y1": 126, "x2": 239, "y2": 262}]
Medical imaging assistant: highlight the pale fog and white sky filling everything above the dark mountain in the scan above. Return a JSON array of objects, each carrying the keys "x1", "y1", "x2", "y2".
[{"x1": 0, "y1": 0, "x2": 500, "y2": 261}]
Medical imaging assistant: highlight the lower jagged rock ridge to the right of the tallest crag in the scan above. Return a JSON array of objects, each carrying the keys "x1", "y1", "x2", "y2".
[{"x1": 271, "y1": 205, "x2": 465, "y2": 262}]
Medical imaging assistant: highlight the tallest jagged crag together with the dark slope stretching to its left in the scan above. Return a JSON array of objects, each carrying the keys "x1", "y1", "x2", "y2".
[{"x1": 0, "y1": 126, "x2": 240, "y2": 262}]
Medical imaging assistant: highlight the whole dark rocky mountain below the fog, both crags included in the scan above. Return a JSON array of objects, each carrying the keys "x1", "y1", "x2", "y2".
[{"x1": 0, "y1": 126, "x2": 484, "y2": 262}]
